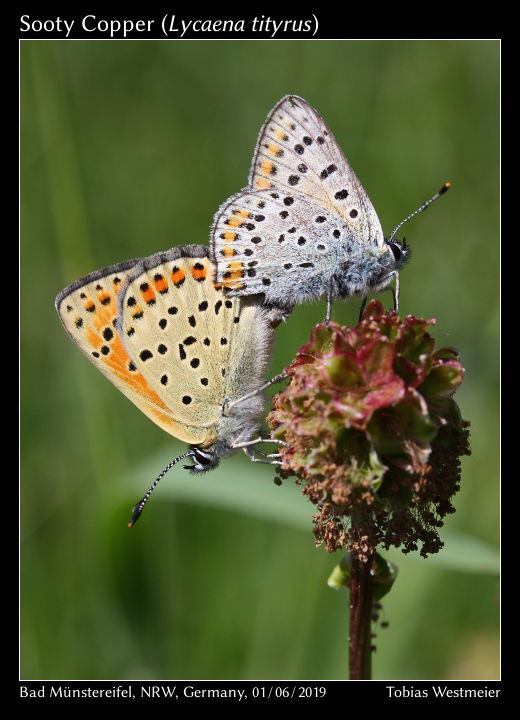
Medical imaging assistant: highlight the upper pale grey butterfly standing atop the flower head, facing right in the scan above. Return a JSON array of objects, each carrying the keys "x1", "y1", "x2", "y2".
[{"x1": 211, "y1": 95, "x2": 449, "y2": 319}]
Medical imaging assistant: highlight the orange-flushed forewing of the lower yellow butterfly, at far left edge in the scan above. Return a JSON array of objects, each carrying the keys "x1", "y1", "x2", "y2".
[{"x1": 56, "y1": 261, "x2": 189, "y2": 437}]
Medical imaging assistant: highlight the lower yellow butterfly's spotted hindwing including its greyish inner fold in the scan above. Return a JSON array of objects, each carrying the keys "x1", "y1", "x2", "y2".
[{"x1": 119, "y1": 245, "x2": 271, "y2": 444}]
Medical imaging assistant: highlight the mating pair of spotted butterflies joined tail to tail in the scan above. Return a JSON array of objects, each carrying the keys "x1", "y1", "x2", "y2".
[{"x1": 56, "y1": 96, "x2": 447, "y2": 525}]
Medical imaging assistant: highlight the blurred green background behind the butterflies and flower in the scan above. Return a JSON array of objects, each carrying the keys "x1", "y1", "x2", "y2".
[{"x1": 21, "y1": 41, "x2": 499, "y2": 679}]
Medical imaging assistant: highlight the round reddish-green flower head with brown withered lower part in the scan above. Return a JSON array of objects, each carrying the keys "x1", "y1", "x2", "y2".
[{"x1": 268, "y1": 301, "x2": 469, "y2": 559}]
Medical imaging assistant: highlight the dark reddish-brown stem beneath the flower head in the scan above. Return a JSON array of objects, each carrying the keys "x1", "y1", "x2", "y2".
[{"x1": 349, "y1": 555, "x2": 374, "y2": 680}]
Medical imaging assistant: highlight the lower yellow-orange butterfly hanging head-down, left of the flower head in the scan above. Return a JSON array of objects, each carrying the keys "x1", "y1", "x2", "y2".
[{"x1": 56, "y1": 245, "x2": 278, "y2": 525}]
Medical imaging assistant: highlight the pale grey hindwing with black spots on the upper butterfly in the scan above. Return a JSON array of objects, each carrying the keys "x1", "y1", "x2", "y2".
[{"x1": 212, "y1": 190, "x2": 355, "y2": 303}]
